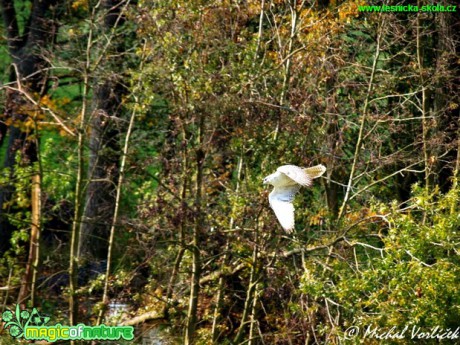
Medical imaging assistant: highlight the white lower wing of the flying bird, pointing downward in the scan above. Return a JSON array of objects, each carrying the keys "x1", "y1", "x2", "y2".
[{"x1": 268, "y1": 184, "x2": 300, "y2": 232}]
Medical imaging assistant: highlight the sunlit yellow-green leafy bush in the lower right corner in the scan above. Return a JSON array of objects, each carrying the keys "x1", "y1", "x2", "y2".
[{"x1": 299, "y1": 186, "x2": 460, "y2": 338}]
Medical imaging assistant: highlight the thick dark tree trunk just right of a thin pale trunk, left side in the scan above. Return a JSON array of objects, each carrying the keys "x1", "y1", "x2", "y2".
[{"x1": 79, "y1": 0, "x2": 129, "y2": 260}]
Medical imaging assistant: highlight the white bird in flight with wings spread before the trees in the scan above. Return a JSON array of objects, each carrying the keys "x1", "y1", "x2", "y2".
[{"x1": 264, "y1": 164, "x2": 326, "y2": 232}]
